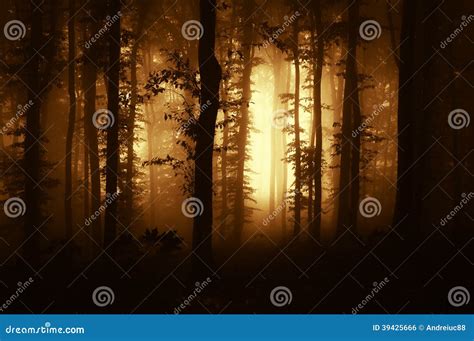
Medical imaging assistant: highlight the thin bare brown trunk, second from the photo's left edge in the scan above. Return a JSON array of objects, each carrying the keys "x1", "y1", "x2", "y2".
[{"x1": 64, "y1": 0, "x2": 76, "y2": 240}]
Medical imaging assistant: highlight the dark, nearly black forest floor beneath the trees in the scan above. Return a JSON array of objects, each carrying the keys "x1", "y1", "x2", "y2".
[{"x1": 0, "y1": 226, "x2": 474, "y2": 314}]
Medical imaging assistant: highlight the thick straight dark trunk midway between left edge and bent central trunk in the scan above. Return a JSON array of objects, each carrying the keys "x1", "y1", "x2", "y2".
[{"x1": 104, "y1": 0, "x2": 121, "y2": 247}]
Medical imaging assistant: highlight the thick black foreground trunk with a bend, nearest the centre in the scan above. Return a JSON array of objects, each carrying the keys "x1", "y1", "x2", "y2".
[{"x1": 193, "y1": 0, "x2": 222, "y2": 275}]
